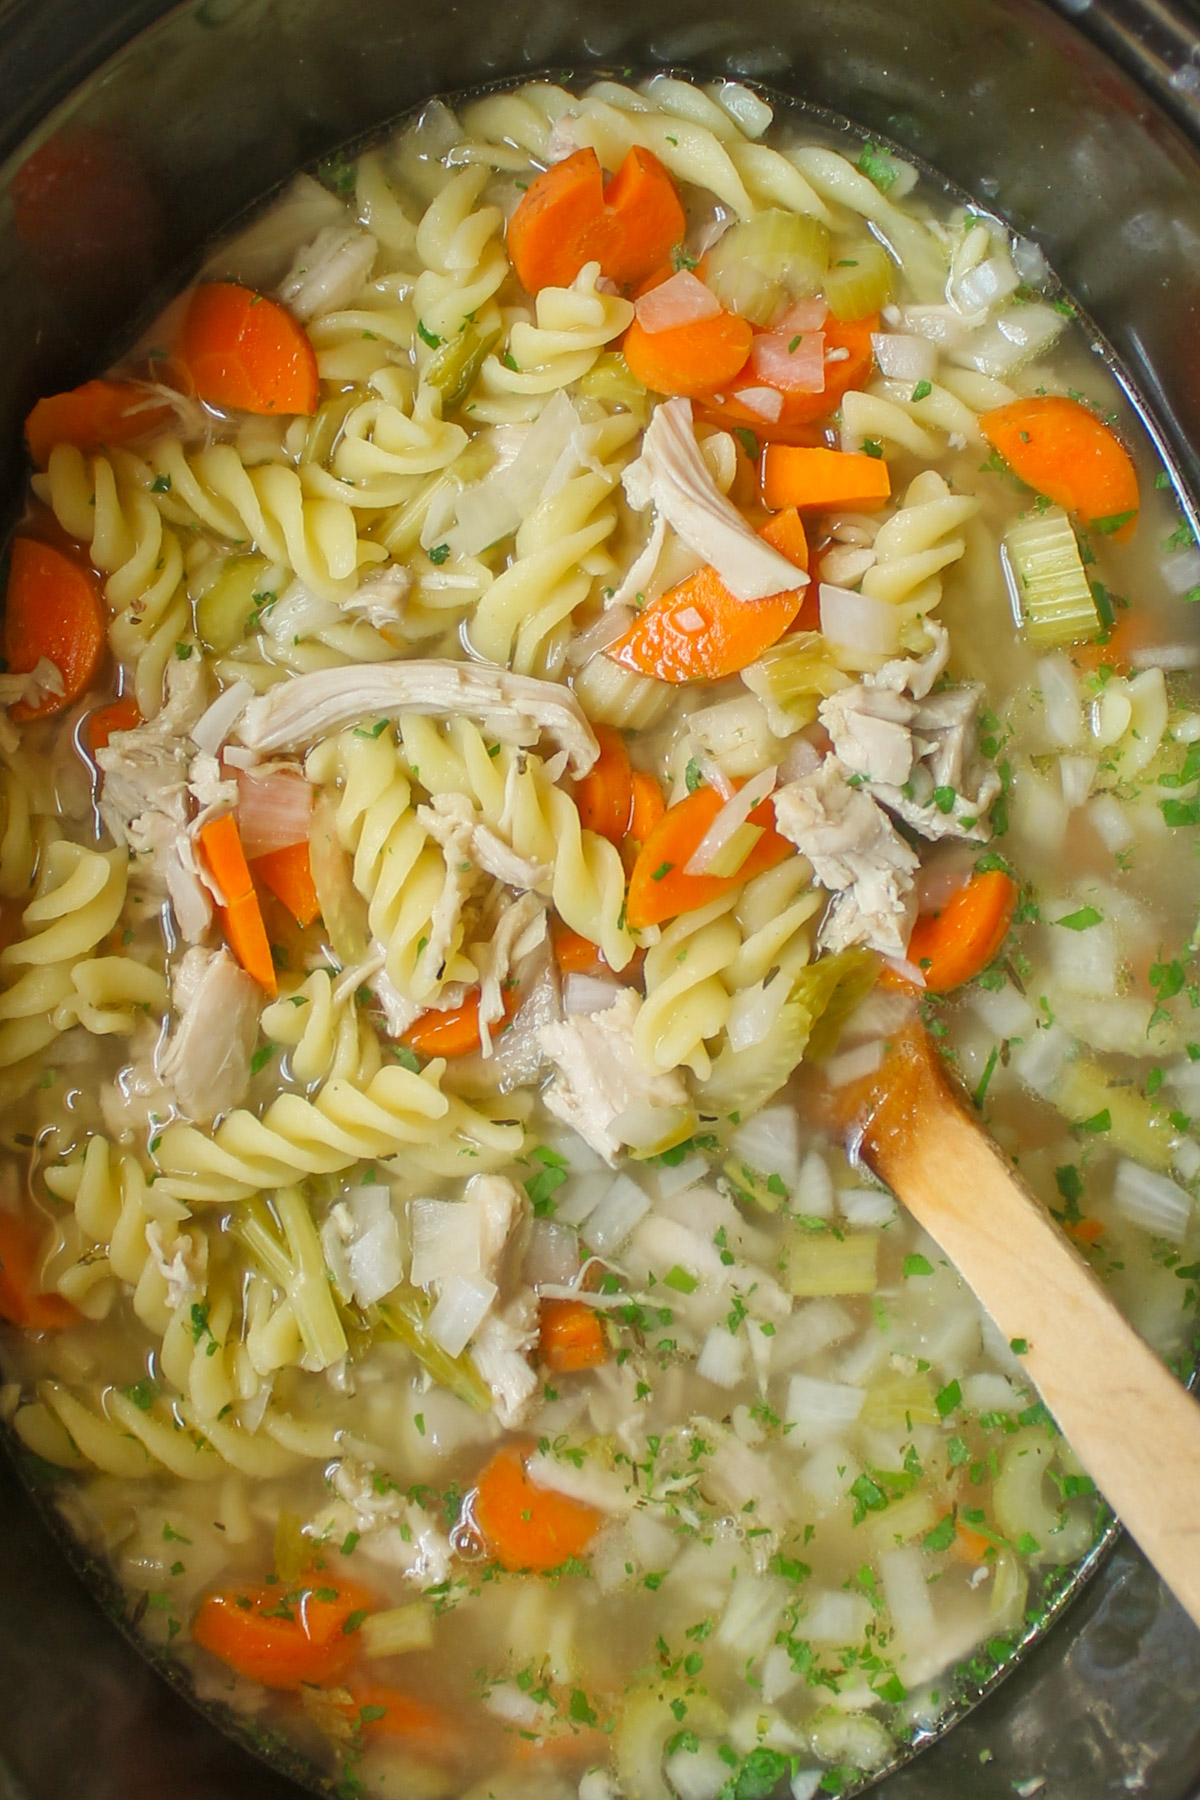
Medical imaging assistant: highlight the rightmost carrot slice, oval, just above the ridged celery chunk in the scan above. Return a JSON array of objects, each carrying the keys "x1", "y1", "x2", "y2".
[{"x1": 979, "y1": 394, "x2": 1139, "y2": 542}]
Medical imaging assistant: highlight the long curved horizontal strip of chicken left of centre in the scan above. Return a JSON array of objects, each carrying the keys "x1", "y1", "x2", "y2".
[{"x1": 237, "y1": 657, "x2": 599, "y2": 776}]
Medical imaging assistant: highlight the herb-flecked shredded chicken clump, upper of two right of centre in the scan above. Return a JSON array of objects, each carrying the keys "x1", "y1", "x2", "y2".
[{"x1": 819, "y1": 626, "x2": 1000, "y2": 842}]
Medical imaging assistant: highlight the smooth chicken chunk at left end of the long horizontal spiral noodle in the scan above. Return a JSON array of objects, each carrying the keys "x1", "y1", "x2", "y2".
[{"x1": 158, "y1": 947, "x2": 259, "y2": 1123}]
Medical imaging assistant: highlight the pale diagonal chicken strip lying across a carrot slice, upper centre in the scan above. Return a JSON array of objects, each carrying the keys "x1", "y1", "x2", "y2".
[{"x1": 621, "y1": 400, "x2": 808, "y2": 599}]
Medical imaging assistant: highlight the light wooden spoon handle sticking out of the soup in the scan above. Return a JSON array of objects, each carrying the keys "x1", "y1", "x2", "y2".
[{"x1": 837, "y1": 1028, "x2": 1200, "y2": 1625}]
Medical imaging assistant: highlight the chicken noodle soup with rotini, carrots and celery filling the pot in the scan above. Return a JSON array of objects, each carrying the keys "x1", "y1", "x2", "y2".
[{"x1": 0, "y1": 63, "x2": 1200, "y2": 1800}]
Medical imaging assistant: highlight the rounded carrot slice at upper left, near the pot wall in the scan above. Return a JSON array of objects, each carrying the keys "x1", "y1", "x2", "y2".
[{"x1": 180, "y1": 281, "x2": 320, "y2": 416}]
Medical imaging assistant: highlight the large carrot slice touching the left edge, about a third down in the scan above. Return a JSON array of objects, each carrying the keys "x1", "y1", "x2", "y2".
[{"x1": 4, "y1": 538, "x2": 104, "y2": 722}]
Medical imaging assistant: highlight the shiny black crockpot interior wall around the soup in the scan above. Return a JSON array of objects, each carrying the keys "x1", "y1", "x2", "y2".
[{"x1": 0, "y1": 0, "x2": 1200, "y2": 1800}]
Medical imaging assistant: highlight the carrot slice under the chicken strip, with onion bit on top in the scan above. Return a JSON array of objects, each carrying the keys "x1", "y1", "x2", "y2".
[{"x1": 606, "y1": 569, "x2": 804, "y2": 686}]
